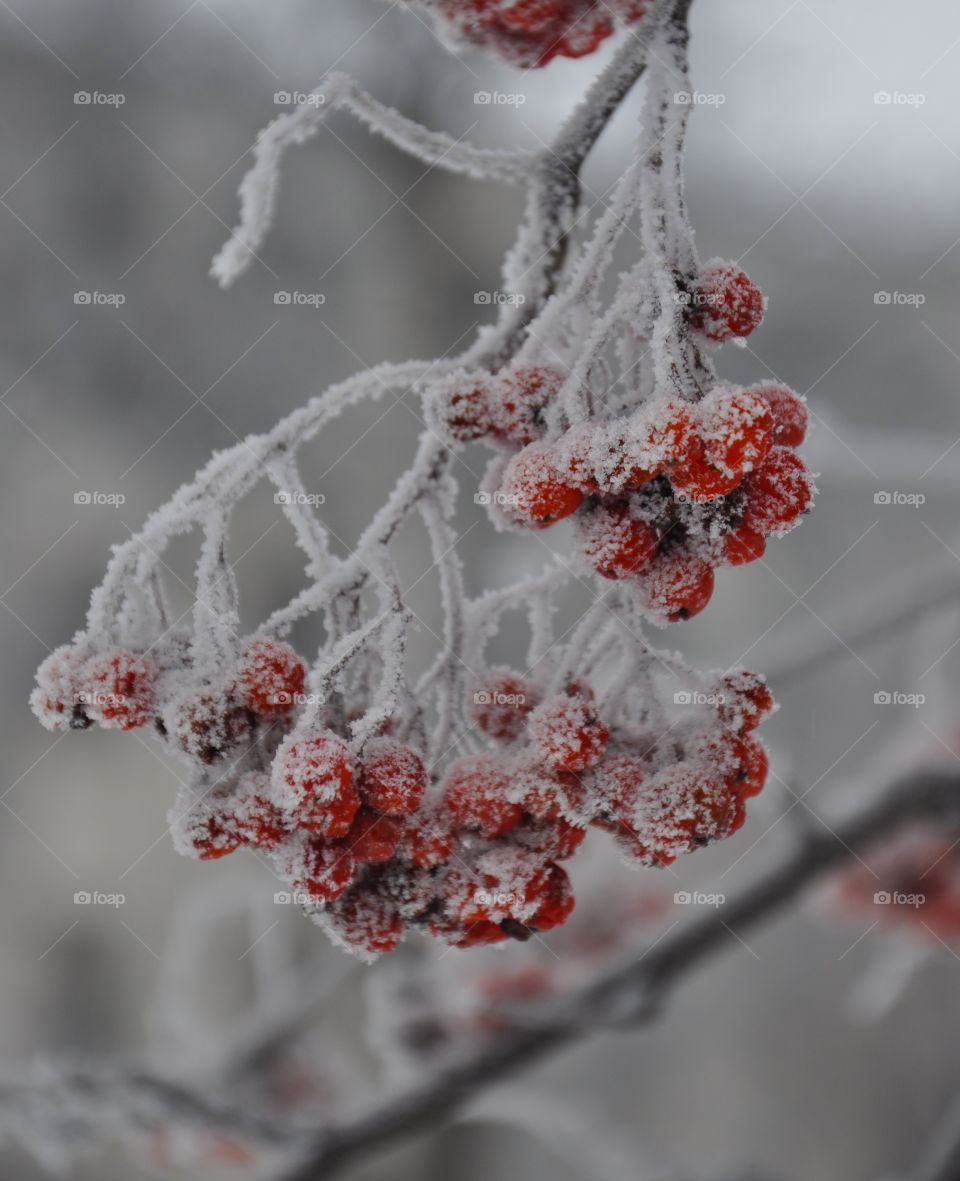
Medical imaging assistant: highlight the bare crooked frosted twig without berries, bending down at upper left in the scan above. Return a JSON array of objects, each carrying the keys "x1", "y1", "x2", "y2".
[{"x1": 210, "y1": 72, "x2": 533, "y2": 287}]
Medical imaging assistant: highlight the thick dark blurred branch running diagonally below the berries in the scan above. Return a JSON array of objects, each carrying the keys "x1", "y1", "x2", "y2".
[{"x1": 282, "y1": 771, "x2": 960, "y2": 1181}]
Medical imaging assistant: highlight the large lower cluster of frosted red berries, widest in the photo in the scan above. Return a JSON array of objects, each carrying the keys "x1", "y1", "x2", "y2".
[{"x1": 32, "y1": 635, "x2": 772, "y2": 957}]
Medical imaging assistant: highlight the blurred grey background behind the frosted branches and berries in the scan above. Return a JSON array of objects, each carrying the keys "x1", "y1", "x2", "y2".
[{"x1": 0, "y1": 0, "x2": 960, "y2": 1181}]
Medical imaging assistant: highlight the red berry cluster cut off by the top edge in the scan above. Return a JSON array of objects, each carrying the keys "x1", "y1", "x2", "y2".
[{"x1": 408, "y1": 0, "x2": 647, "y2": 70}]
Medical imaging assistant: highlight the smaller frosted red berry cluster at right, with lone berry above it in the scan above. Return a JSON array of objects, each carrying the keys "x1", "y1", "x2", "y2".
[{"x1": 433, "y1": 263, "x2": 815, "y2": 624}]
